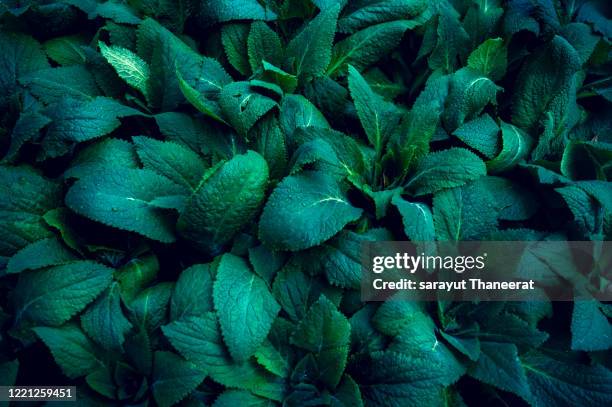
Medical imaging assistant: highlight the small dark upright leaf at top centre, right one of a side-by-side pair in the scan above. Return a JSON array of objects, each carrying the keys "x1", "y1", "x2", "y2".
[{"x1": 247, "y1": 21, "x2": 283, "y2": 72}]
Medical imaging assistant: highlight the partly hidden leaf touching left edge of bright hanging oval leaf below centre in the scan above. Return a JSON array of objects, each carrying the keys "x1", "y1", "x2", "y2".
[{"x1": 170, "y1": 264, "x2": 213, "y2": 321}]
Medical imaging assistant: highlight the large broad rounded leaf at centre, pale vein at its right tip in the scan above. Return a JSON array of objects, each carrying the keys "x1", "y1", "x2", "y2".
[{"x1": 259, "y1": 171, "x2": 362, "y2": 251}]
